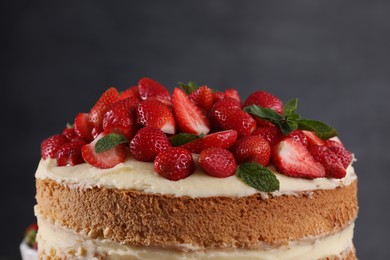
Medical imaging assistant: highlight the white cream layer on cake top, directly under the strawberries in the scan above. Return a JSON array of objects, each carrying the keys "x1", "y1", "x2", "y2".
[{"x1": 35, "y1": 153, "x2": 356, "y2": 198}]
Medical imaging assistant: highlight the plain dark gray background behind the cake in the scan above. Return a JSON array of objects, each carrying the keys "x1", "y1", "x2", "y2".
[{"x1": 0, "y1": 0, "x2": 390, "y2": 259}]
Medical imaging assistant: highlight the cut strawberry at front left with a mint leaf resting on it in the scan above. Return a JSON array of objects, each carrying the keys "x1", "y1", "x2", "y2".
[{"x1": 81, "y1": 132, "x2": 126, "y2": 169}]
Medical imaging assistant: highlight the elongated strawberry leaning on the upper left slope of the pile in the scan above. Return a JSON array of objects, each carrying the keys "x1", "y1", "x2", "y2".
[{"x1": 88, "y1": 87, "x2": 119, "y2": 126}]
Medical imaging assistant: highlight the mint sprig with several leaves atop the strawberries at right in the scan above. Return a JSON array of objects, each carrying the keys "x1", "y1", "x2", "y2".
[{"x1": 244, "y1": 99, "x2": 337, "y2": 140}]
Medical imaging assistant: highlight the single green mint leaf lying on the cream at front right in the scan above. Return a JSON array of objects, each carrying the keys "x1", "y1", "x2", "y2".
[{"x1": 236, "y1": 162, "x2": 279, "y2": 192}]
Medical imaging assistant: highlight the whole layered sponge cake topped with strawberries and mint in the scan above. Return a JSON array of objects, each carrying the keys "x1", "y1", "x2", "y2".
[{"x1": 34, "y1": 78, "x2": 358, "y2": 259}]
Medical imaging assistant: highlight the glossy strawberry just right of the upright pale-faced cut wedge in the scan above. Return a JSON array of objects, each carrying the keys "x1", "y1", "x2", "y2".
[{"x1": 210, "y1": 106, "x2": 256, "y2": 137}]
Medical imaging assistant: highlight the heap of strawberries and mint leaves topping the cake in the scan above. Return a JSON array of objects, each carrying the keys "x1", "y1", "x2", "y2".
[{"x1": 41, "y1": 78, "x2": 352, "y2": 192}]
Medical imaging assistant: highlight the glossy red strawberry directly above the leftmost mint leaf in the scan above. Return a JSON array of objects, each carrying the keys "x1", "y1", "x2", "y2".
[{"x1": 103, "y1": 97, "x2": 139, "y2": 140}]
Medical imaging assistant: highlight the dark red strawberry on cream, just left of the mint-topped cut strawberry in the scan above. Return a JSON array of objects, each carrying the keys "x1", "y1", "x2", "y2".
[{"x1": 56, "y1": 137, "x2": 87, "y2": 166}]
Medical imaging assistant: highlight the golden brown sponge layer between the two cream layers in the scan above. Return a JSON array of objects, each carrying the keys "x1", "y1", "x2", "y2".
[{"x1": 36, "y1": 179, "x2": 357, "y2": 248}]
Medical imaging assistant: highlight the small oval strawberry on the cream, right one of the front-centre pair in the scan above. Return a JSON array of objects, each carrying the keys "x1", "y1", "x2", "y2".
[{"x1": 198, "y1": 148, "x2": 237, "y2": 178}]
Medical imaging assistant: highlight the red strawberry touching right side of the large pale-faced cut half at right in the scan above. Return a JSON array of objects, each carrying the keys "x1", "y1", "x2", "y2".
[{"x1": 309, "y1": 145, "x2": 346, "y2": 179}]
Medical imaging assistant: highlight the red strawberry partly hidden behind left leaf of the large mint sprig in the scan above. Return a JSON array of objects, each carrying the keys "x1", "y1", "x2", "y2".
[{"x1": 244, "y1": 91, "x2": 283, "y2": 126}]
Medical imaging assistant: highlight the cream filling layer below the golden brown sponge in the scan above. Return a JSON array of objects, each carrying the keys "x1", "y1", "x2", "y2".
[{"x1": 36, "y1": 209, "x2": 354, "y2": 260}]
